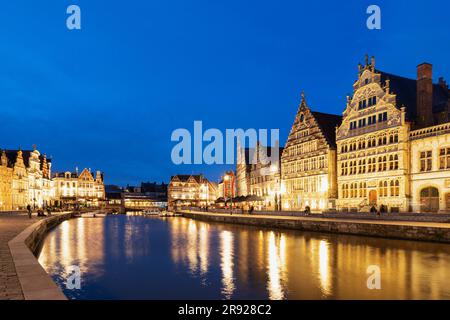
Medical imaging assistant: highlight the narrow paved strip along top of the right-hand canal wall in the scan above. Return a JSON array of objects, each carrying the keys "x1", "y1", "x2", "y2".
[{"x1": 180, "y1": 210, "x2": 450, "y2": 229}]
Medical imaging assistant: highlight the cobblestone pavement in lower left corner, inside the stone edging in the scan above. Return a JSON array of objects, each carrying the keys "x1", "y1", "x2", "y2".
[{"x1": 0, "y1": 212, "x2": 38, "y2": 300}]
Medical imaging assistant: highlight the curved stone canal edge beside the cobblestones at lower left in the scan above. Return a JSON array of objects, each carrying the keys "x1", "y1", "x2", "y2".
[{"x1": 8, "y1": 212, "x2": 73, "y2": 300}]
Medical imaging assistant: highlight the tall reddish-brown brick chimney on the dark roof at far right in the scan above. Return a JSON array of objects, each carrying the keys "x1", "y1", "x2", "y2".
[{"x1": 416, "y1": 63, "x2": 433, "y2": 127}]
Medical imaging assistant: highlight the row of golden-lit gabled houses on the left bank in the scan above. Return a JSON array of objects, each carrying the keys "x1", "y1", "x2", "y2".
[{"x1": 0, "y1": 148, "x2": 105, "y2": 211}]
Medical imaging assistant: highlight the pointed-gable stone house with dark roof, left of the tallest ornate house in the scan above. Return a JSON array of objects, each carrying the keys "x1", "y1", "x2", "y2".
[{"x1": 281, "y1": 94, "x2": 342, "y2": 211}]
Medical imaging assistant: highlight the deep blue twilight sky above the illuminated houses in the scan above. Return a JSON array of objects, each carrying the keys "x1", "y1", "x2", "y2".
[{"x1": 0, "y1": 0, "x2": 450, "y2": 184}]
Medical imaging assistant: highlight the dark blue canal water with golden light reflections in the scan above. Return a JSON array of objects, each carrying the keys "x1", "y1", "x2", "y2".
[{"x1": 39, "y1": 215, "x2": 450, "y2": 299}]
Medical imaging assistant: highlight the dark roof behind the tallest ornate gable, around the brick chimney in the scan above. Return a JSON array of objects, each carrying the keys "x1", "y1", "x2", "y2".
[{"x1": 376, "y1": 70, "x2": 450, "y2": 120}]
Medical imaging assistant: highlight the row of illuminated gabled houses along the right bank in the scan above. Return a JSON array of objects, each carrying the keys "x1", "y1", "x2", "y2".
[{"x1": 169, "y1": 56, "x2": 450, "y2": 212}]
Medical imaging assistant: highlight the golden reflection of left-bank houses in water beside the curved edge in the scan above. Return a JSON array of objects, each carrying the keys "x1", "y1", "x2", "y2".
[{"x1": 39, "y1": 218, "x2": 105, "y2": 277}]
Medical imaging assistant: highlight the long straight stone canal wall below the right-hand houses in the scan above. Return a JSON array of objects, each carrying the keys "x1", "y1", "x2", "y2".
[{"x1": 178, "y1": 211, "x2": 450, "y2": 243}]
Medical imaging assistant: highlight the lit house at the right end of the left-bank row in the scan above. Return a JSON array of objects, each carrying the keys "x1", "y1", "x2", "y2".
[{"x1": 53, "y1": 168, "x2": 105, "y2": 207}]
